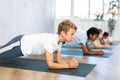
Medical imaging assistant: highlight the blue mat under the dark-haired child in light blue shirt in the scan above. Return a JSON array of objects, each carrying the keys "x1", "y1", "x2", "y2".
[{"x1": 61, "y1": 50, "x2": 112, "y2": 58}]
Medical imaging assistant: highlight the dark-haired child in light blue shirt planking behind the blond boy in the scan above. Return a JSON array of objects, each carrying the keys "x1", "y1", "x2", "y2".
[{"x1": 64, "y1": 27, "x2": 103, "y2": 55}]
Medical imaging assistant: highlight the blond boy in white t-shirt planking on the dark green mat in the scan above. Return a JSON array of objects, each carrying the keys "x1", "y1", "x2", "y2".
[{"x1": 0, "y1": 20, "x2": 79, "y2": 69}]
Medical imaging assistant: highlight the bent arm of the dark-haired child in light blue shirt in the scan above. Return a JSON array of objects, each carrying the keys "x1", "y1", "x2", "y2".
[{"x1": 81, "y1": 44, "x2": 104, "y2": 55}]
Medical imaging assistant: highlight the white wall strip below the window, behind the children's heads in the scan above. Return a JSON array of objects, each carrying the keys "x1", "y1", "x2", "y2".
[{"x1": 54, "y1": 19, "x2": 108, "y2": 33}]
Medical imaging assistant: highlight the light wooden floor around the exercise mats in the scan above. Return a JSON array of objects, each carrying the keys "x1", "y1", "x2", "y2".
[{"x1": 0, "y1": 45, "x2": 120, "y2": 80}]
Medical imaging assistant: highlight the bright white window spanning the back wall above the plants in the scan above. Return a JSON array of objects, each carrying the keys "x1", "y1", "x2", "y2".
[{"x1": 56, "y1": 0, "x2": 117, "y2": 19}]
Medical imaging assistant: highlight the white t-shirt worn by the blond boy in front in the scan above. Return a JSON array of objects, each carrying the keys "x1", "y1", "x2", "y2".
[{"x1": 21, "y1": 33, "x2": 62, "y2": 55}]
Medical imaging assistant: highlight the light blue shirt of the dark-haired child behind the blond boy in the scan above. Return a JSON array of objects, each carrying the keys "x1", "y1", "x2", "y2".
[{"x1": 63, "y1": 30, "x2": 88, "y2": 47}]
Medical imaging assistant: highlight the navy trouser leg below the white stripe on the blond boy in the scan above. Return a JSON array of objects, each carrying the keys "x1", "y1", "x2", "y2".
[{"x1": 0, "y1": 46, "x2": 23, "y2": 59}]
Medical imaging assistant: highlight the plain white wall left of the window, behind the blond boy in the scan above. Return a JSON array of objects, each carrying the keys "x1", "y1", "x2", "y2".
[{"x1": 0, "y1": 0, "x2": 54, "y2": 44}]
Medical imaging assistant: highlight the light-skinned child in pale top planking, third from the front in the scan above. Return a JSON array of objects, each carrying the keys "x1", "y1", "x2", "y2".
[{"x1": 92, "y1": 29, "x2": 109, "y2": 48}]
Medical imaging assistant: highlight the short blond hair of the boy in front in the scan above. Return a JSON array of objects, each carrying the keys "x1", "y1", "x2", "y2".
[{"x1": 58, "y1": 19, "x2": 77, "y2": 34}]
